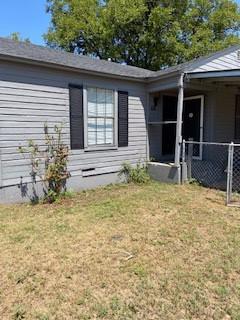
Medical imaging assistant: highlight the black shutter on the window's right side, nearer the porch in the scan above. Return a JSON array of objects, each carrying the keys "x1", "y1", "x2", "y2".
[{"x1": 118, "y1": 91, "x2": 128, "y2": 147}]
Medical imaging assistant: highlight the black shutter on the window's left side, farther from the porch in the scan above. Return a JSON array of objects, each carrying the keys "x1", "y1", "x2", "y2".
[{"x1": 69, "y1": 85, "x2": 84, "y2": 150}]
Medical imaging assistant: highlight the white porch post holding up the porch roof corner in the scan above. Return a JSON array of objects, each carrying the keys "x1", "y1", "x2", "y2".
[{"x1": 174, "y1": 73, "x2": 184, "y2": 168}]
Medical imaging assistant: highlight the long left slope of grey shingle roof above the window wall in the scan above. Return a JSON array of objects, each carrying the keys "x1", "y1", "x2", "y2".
[{"x1": 0, "y1": 37, "x2": 154, "y2": 79}]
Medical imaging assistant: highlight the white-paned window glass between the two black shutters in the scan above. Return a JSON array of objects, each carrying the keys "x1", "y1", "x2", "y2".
[{"x1": 85, "y1": 87, "x2": 116, "y2": 147}]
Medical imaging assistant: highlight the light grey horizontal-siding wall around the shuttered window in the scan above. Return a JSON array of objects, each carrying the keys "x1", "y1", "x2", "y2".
[{"x1": 0, "y1": 62, "x2": 147, "y2": 202}]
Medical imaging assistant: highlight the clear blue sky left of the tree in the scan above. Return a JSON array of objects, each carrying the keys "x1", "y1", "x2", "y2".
[{"x1": 0, "y1": 0, "x2": 240, "y2": 45}]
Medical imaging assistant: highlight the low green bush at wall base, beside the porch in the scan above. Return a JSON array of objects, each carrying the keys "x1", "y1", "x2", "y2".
[{"x1": 119, "y1": 161, "x2": 150, "y2": 184}]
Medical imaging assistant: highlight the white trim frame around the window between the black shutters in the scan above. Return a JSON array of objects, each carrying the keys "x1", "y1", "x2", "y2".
[{"x1": 83, "y1": 85, "x2": 118, "y2": 151}]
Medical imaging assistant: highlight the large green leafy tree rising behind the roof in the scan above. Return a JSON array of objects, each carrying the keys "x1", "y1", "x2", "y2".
[{"x1": 45, "y1": 0, "x2": 240, "y2": 70}]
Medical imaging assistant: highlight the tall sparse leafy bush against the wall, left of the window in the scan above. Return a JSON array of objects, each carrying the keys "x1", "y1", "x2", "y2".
[{"x1": 19, "y1": 124, "x2": 70, "y2": 203}]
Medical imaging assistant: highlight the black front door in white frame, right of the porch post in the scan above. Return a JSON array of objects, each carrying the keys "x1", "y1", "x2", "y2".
[{"x1": 182, "y1": 96, "x2": 203, "y2": 159}]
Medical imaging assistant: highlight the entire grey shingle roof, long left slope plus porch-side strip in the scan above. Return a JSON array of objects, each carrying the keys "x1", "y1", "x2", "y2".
[{"x1": 0, "y1": 37, "x2": 240, "y2": 81}]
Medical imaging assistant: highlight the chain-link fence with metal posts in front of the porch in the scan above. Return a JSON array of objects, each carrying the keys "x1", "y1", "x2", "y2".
[{"x1": 182, "y1": 141, "x2": 240, "y2": 205}]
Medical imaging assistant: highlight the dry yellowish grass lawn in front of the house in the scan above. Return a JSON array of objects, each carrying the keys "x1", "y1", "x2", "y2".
[{"x1": 0, "y1": 182, "x2": 240, "y2": 320}]
